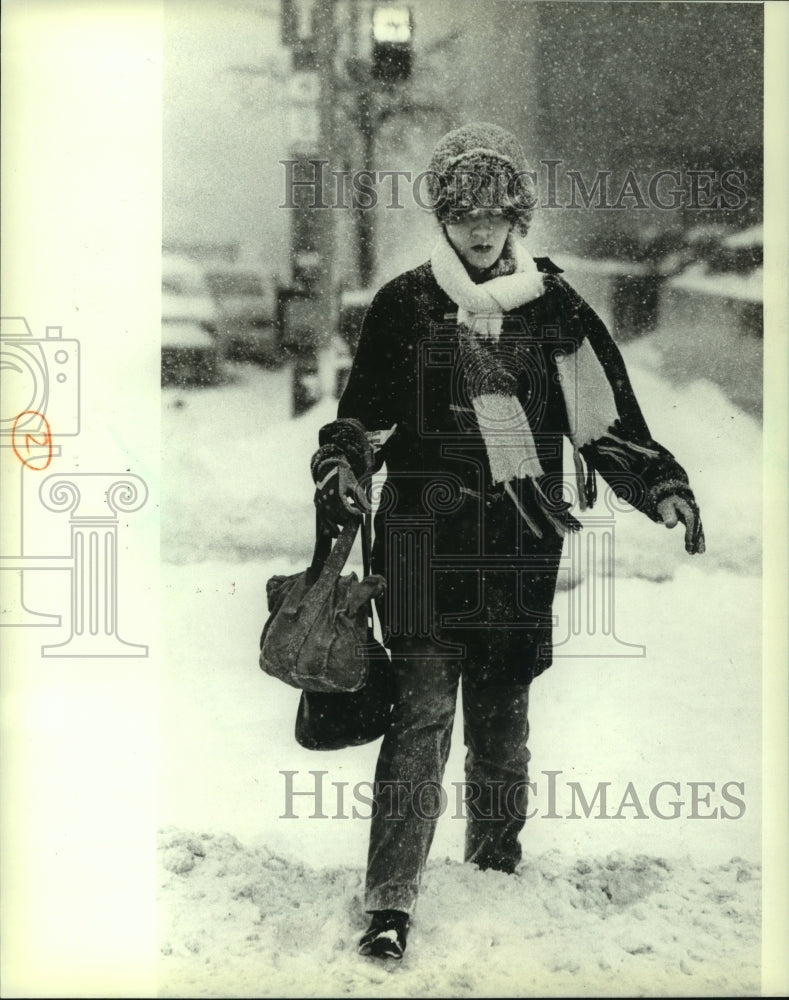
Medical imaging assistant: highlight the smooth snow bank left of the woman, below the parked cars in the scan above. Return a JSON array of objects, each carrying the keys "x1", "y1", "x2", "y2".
[{"x1": 162, "y1": 365, "x2": 337, "y2": 563}]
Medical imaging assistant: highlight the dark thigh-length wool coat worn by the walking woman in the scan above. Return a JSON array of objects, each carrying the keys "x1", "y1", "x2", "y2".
[{"x1": 338, "y1": 258, "x2": 692, "y2": 683}]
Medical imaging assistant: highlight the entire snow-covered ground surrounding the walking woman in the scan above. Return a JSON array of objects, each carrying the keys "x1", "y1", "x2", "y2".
[{"x1": 159, "y1": 341, "x2": 761, "y2": 996}]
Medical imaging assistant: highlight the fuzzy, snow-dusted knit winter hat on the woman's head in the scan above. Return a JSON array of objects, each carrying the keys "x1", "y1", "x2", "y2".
[{"x1": 427, "y1": 122, "x2": 537, "y2": 235}]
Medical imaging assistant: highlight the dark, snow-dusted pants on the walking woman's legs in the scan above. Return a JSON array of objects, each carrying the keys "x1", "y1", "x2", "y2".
[{"x1": 365, "y1": 646, "x2": 529, "y2": 913}]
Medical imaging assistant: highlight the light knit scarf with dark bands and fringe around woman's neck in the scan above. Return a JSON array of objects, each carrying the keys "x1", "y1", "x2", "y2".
[{"x1": 430, "y1": 229, "x2": 646, "y2": 536}]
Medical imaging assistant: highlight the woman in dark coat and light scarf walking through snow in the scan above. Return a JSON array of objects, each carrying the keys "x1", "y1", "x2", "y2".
[{"x1": 312, "y1": 123, "x2": 704, "y2": 958}]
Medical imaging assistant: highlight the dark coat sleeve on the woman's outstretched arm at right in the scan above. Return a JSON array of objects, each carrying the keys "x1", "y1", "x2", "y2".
[{"x1": 560, "y1": 279, "x2": 696, "y2": 521}]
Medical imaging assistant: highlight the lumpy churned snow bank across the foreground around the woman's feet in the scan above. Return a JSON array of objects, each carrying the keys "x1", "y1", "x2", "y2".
[{"x1": 159, "y1": 828, "x2": 761, "y2": 997}]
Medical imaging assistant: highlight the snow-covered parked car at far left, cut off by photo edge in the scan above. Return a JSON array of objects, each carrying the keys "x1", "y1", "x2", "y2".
[{"x1": 161, "y1": 254, "x2": 224, "y2": 385}]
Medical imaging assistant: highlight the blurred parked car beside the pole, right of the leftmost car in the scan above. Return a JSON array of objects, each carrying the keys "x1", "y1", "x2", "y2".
[{"x1": 206, "y1": 264, "x2": 281, "y2": 364}]
